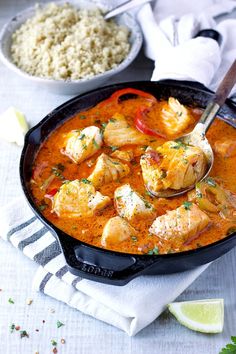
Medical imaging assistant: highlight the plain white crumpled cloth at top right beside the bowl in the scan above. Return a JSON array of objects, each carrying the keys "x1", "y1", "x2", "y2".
[{"x1": 137, "y1": 0, "x2": 236, "y2": 92}]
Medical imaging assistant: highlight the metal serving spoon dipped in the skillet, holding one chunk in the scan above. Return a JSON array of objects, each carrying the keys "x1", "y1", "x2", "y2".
[{"x1": 149, "y1": 60, "x2": 236, "y2": 198}]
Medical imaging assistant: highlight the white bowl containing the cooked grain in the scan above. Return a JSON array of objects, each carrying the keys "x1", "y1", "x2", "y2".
[{"x1": 0, "y1": 0, "x2": 142, "y2": 94}]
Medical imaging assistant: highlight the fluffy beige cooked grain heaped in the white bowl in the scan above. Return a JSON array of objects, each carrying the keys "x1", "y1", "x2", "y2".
[{"x1": 11, "y1": 3, "x2": 130, "y2": 80}]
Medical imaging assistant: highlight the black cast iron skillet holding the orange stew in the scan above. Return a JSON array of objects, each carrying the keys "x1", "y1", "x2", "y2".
[{"x1": 20, "y1": 80, "x2": 236, "y2": 285}]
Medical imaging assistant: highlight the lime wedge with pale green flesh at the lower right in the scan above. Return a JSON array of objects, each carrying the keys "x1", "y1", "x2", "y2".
[{"x1": 168, "y1": 299, "x2": 224, "y2": 333}]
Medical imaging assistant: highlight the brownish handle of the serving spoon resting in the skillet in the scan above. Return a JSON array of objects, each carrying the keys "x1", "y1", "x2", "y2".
[{"x1": 199, "y1": 60, "x2": 236, "y2": 133}]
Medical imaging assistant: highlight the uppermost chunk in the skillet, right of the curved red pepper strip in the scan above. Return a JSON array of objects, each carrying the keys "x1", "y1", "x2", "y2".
[{"x1": 161, "y1": 97, "x2": 192, "y2": 135}]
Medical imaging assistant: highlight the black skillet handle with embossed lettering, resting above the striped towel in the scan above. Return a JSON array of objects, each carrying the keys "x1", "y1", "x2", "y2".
[{"x1": 53, "y1": 230, "x2": 160, "y2": 285}]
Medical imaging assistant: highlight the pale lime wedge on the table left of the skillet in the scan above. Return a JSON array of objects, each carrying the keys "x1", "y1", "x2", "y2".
[{"x1": 0, "y1": 107, "x2": 29, "y2": 145}]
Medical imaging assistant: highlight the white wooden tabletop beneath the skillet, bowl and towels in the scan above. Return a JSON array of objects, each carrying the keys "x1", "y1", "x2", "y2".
[{"x1": 0, "y1": 0, "x2": 236, "y2": 354}]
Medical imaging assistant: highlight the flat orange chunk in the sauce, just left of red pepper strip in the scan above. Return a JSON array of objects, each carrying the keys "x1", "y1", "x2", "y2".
[{"x1": 104, "y1": 113, "x2": 150, "y2": 147}]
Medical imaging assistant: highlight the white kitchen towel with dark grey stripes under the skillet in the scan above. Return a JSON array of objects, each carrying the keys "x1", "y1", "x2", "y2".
[{"x1": 0, "y1": 198, "x2": 208, "y2": 336}]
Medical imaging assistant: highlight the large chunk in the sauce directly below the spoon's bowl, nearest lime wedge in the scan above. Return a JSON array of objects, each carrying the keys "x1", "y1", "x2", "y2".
[{"x1": 149, "y1": 202, "x2": 210, "y2": 243}]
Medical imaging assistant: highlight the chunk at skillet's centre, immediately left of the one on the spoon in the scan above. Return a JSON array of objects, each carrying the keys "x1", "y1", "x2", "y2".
[{"x1": 88, "y1": 153, "x2": 130, "y2": 188}]
